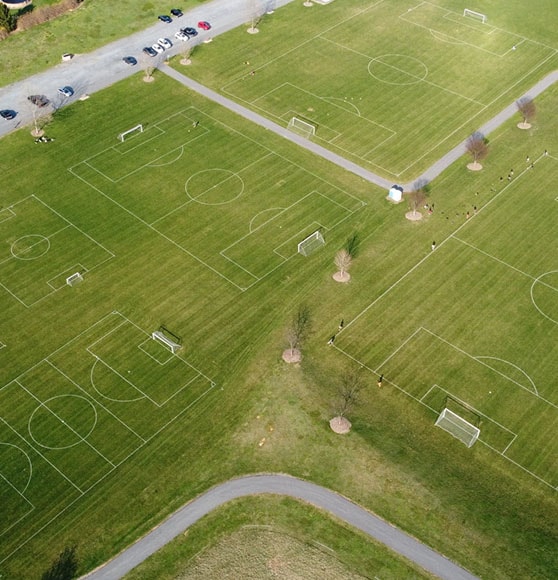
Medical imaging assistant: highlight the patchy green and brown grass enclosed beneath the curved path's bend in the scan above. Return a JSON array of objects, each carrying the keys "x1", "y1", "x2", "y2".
[{"x1": 127, "y1": 496, "x2": 430, "y2": 580}]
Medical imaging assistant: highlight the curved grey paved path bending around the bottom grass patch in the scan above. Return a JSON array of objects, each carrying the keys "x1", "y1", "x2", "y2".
[{"x1": 83, "y1": 475, "x2": 477, "y2": 580}]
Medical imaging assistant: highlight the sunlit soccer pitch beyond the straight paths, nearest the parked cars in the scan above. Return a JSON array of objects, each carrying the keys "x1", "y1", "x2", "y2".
[{"x1": 192, "y1": 1, "x2": 556, "y2": 181}]
